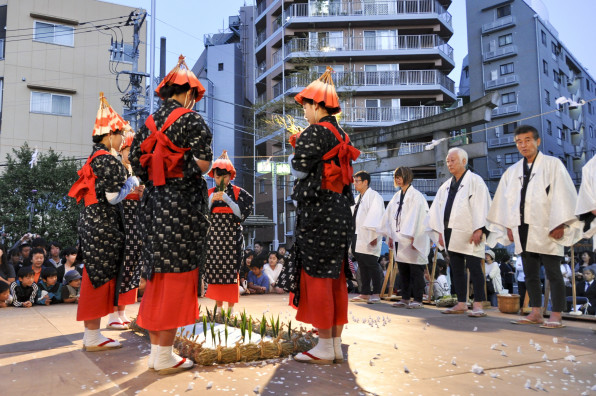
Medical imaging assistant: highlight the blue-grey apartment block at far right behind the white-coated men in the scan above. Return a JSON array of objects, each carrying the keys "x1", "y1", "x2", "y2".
[{"x1": 464, "y1": 0, "x2": 596, "y2": 192}]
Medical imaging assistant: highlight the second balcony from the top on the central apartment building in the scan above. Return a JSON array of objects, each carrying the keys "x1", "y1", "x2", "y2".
[{"x1": 285, "y1": 34, "x2": 453, "y2": 61}]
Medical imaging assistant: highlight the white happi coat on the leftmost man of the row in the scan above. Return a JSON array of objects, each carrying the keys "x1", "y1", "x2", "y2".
[{"x1": 352, "y1": 188, "x2": 385, "y2": 257}]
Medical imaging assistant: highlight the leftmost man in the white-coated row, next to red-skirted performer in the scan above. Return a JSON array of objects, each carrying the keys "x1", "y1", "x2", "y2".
[{"x1": 350, "y1": 171, "x2": 385, "y2": 304}]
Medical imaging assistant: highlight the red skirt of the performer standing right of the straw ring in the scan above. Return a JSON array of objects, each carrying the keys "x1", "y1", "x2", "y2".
[{"x1": 296, "y1": 270, "x2": 348, "y2": 330}]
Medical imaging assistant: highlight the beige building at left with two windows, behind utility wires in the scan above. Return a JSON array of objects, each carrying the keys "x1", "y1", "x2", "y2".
[{"x1": 0, "y1": 0, "x2": 147, "y2": 163}]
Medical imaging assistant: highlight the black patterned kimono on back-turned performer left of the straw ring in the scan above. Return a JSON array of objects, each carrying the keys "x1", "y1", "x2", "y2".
[{"x1": 128, "y1": 99, "x2": 213, "y2": 278}]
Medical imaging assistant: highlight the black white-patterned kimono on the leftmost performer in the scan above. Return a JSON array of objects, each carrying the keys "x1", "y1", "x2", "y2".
[{"x1": 77, "y1": 143, "x2": 126, "y2": 288}]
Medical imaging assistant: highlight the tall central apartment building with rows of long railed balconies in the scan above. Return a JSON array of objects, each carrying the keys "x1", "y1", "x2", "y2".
[{"x1": 255, "y1": 0, "x2": 456, "y2": 248}]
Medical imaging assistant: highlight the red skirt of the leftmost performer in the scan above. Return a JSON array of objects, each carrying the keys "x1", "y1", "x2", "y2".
[{"x1": 77, "y1": 268, "x2": 116, "y2": 321}]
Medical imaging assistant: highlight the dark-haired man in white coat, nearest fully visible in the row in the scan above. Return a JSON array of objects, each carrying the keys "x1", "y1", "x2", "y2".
[{"x1": 487, "y1": 125, "x2": 581, "y2": 329}]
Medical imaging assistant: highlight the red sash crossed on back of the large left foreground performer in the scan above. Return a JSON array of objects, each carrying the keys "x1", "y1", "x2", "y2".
[{"x1": 141, "y1": 107, "x2": 192, "y2": 186}]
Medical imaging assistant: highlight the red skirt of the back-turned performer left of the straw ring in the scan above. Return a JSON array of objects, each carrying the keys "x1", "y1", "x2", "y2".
[{"x1": 137, "y1": 268, "x2": 199, "y2": 331}]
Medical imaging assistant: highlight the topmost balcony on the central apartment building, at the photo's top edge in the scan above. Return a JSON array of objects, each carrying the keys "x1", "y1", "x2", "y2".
[{"x1": 286, "y1": 0, "x2": 452, "y2": 29}]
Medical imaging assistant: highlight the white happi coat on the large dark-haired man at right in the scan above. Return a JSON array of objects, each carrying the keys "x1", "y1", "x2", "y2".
[{"x1": 487, "y1": 152, "x2": 581, "y2": 257}]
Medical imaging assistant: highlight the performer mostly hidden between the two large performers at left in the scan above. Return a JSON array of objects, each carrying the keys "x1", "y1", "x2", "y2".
[{"x1": 108, "y1": 128, "x2": 145, "y2": 330}]
